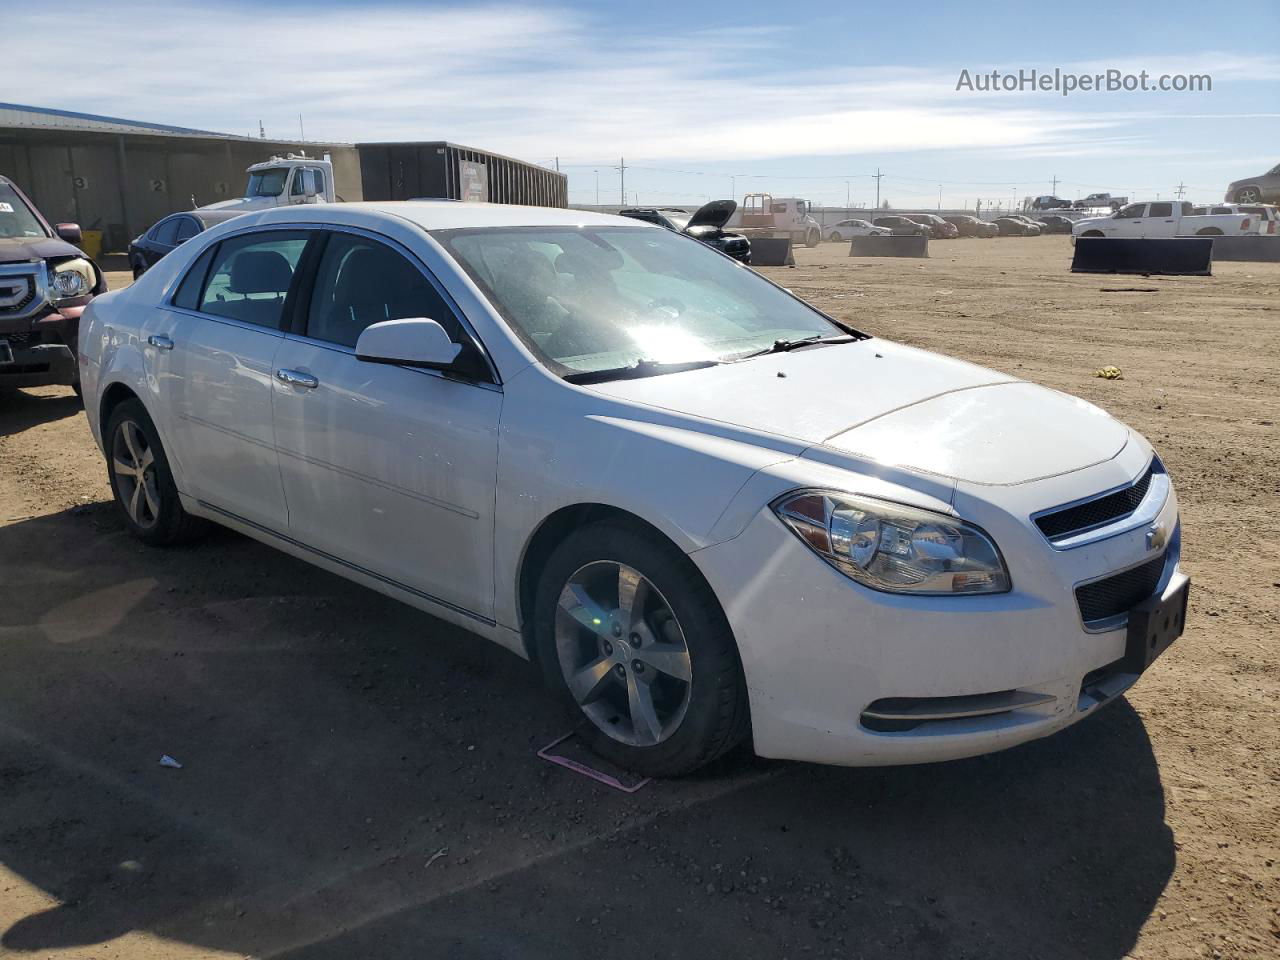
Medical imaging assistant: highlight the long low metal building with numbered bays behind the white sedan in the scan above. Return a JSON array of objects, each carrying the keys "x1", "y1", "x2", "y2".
[{"x1": 0, "y1": 102, "x2": 362, "y2": 250}]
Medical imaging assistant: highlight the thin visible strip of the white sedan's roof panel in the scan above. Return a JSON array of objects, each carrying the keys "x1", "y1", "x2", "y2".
[{"x1": 225, "y1": 200, "x2": 662, "y2": 230}]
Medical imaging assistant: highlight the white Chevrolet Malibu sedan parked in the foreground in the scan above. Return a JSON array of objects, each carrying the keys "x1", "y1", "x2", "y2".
[{"x1": 79, "y1": 202, "x2": 1188, "y2": 774}]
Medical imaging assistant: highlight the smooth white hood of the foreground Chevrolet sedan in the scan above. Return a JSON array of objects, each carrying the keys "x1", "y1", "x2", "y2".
[{"x1": 591, "y1": 339, "x2": 1129, "y2": 484}]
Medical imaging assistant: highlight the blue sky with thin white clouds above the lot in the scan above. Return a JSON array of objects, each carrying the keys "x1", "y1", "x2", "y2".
[{"x1": 0, "y1": 0, "x2": 1280, "y2": 207}]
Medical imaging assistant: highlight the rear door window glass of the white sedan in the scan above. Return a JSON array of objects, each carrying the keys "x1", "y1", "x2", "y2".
[{"x1": 197, "y1": 230, "x2": 311, "y2": 330}]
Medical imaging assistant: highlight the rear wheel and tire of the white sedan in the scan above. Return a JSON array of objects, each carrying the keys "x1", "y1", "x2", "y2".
[{"x1": 104, "y1": 399, "x2": 209, "y2": 547}]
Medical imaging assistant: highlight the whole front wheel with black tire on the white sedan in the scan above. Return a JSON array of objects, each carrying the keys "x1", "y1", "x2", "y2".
[{"x1": 534, "y1": 521, "x2": 749, "y2": 777}]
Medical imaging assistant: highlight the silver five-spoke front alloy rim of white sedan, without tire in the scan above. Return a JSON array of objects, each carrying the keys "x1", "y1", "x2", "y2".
[{"x1": 556, "y1": 561, "x2": 692, "y2": 746}]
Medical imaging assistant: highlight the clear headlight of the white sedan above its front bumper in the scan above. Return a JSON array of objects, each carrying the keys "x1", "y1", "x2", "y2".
[{"x1": 773, "y1": 490, "x2": 1010, "y2": 594}]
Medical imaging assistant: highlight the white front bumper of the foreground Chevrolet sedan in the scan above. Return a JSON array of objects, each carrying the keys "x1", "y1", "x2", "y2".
[{"x1": 690, "y1": 455, "x2": 1187, "y2": 765}]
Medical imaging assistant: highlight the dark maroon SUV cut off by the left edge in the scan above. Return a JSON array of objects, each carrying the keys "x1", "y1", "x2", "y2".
[{"x1": 0, "y1": 177, "x2": 106, "y2": 393}]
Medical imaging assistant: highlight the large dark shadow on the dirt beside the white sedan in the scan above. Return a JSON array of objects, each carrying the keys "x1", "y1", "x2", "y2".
[{"x1": 0, "y1": 503, "x2": 1174, "y2": 960}]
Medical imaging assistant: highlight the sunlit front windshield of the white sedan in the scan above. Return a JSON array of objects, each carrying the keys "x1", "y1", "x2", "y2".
[{"x1": 436, "y1": 227, "x2": 846, "y2": 374}]
